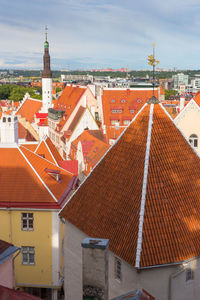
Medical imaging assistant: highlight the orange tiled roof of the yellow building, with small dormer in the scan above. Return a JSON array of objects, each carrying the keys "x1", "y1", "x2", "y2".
[{"x1": 0, "y1": 146, "x2": 73, "y2": 208}]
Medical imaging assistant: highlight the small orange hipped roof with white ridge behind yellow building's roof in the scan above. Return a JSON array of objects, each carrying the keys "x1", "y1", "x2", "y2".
[{"x1": 35, "y1": 136, "x2": 62, "y2": 165}]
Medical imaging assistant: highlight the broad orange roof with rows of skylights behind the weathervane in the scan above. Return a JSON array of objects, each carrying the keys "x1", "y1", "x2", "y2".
[{"x1": 102, "y1": 89, "x2": 158, "y2": 141}]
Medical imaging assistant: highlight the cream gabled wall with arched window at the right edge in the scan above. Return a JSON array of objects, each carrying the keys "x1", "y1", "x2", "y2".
[{"x1": 174, "y1": 100, "x2": 200, "y2": 154}]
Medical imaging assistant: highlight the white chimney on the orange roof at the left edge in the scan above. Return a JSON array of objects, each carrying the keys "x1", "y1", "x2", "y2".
[{"x1": 0, "y1": 113, "x2": 18, "y2": 144}]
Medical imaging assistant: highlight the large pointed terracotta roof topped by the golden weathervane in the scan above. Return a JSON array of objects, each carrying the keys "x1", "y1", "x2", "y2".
[{"x1": 60, "y1": 104, "x2": 200, "y2": 268}]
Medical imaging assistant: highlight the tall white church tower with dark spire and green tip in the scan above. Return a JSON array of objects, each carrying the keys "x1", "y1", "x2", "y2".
[{"x1": 42, "y1": 26, "x2": 52, "y2": 113}]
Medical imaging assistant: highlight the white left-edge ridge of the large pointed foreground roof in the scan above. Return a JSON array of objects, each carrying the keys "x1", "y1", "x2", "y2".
[{"x1": 59, "y1": 103, "x2": 147, "y2": 214}]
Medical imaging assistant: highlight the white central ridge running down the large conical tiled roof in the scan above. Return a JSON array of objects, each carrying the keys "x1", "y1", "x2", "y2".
[{"x1": 135, "y1": 103, "x2": 154, "y2": 268}]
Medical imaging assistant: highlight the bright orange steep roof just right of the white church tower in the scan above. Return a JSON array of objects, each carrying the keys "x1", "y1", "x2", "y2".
[{"x1": 54, "y1": 86, "x2": 86, "y2": 131}]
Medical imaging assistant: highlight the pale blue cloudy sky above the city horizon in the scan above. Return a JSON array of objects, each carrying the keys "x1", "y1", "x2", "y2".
[{"x1": 0, "y1": 0, "x2": 200, "y2": 70}]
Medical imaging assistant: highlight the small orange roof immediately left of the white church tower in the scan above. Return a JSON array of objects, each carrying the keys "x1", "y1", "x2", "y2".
[{"x1": 16, "y1": 99, "x2": 42, "y2": 123}]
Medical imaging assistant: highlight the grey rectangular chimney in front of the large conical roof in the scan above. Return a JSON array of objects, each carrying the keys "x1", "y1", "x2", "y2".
[{"x1": 81, "y1": 238, "x2": 109, "y2": 300}]
